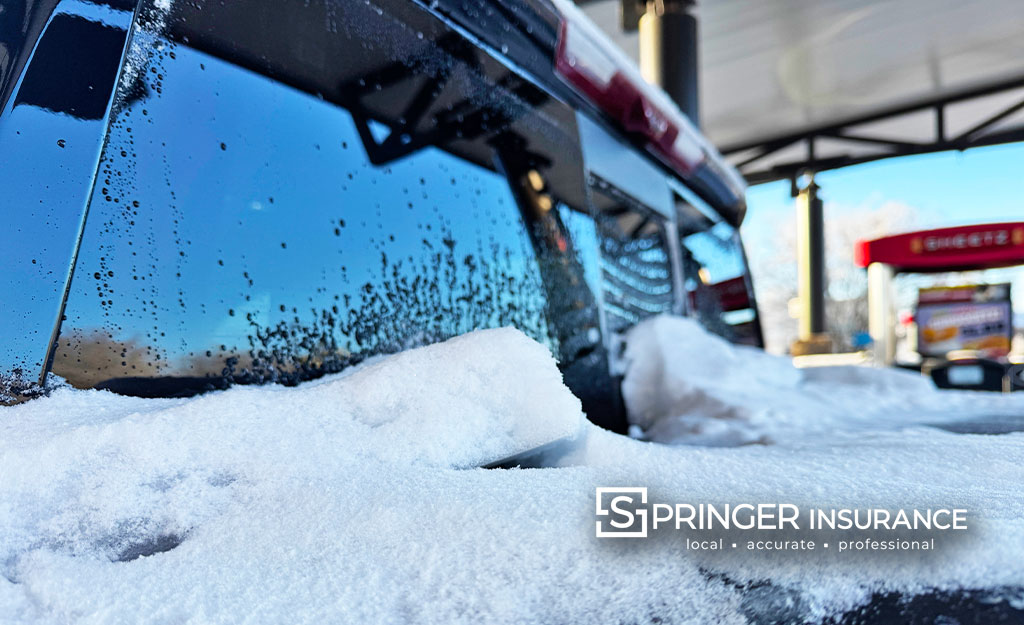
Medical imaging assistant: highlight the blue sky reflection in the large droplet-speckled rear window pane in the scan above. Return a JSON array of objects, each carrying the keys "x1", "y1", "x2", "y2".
[{"x1": 61, "y1": 34, "x2": 537, "y2": 364}]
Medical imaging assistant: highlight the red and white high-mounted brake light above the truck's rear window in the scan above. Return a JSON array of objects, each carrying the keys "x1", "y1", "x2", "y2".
[{"x1": 555, "y1": 1, "x2": 707, "y2": 174}]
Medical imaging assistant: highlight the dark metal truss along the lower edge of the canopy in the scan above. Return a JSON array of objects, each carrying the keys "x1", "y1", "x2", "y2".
[{"x1": 720, "y1": 75, "x2": 1024, "y2": 184}]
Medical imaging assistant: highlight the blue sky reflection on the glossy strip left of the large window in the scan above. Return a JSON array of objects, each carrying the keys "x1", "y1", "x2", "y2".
[{"x1": 0, "y1": 0, "x2": 131, "y2": 376}]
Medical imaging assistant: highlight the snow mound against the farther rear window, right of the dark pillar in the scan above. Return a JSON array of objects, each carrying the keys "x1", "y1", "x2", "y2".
[{"x1": 623, "y1": 317, "x2": 1024, "y2": 446}]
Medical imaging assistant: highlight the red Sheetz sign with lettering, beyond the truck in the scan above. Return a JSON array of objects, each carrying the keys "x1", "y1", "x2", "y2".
[{"x1": 854, "y1": 221, "x2": 1024, "y2": 272}]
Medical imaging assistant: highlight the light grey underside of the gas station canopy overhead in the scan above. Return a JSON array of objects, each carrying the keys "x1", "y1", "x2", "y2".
[{"x1": 580, "y1": 0, "x2": 1024, "y2": 183}]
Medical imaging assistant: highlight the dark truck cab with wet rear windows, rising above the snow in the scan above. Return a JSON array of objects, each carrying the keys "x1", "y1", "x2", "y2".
[{"x1": 0, "y1": 0, "x2": 762, "y2": 430}]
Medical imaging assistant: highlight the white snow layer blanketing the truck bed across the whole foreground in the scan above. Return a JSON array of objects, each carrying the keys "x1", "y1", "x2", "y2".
[{"x1": 0, "y1": 319, "x2": 1024, "y2": 624}]
